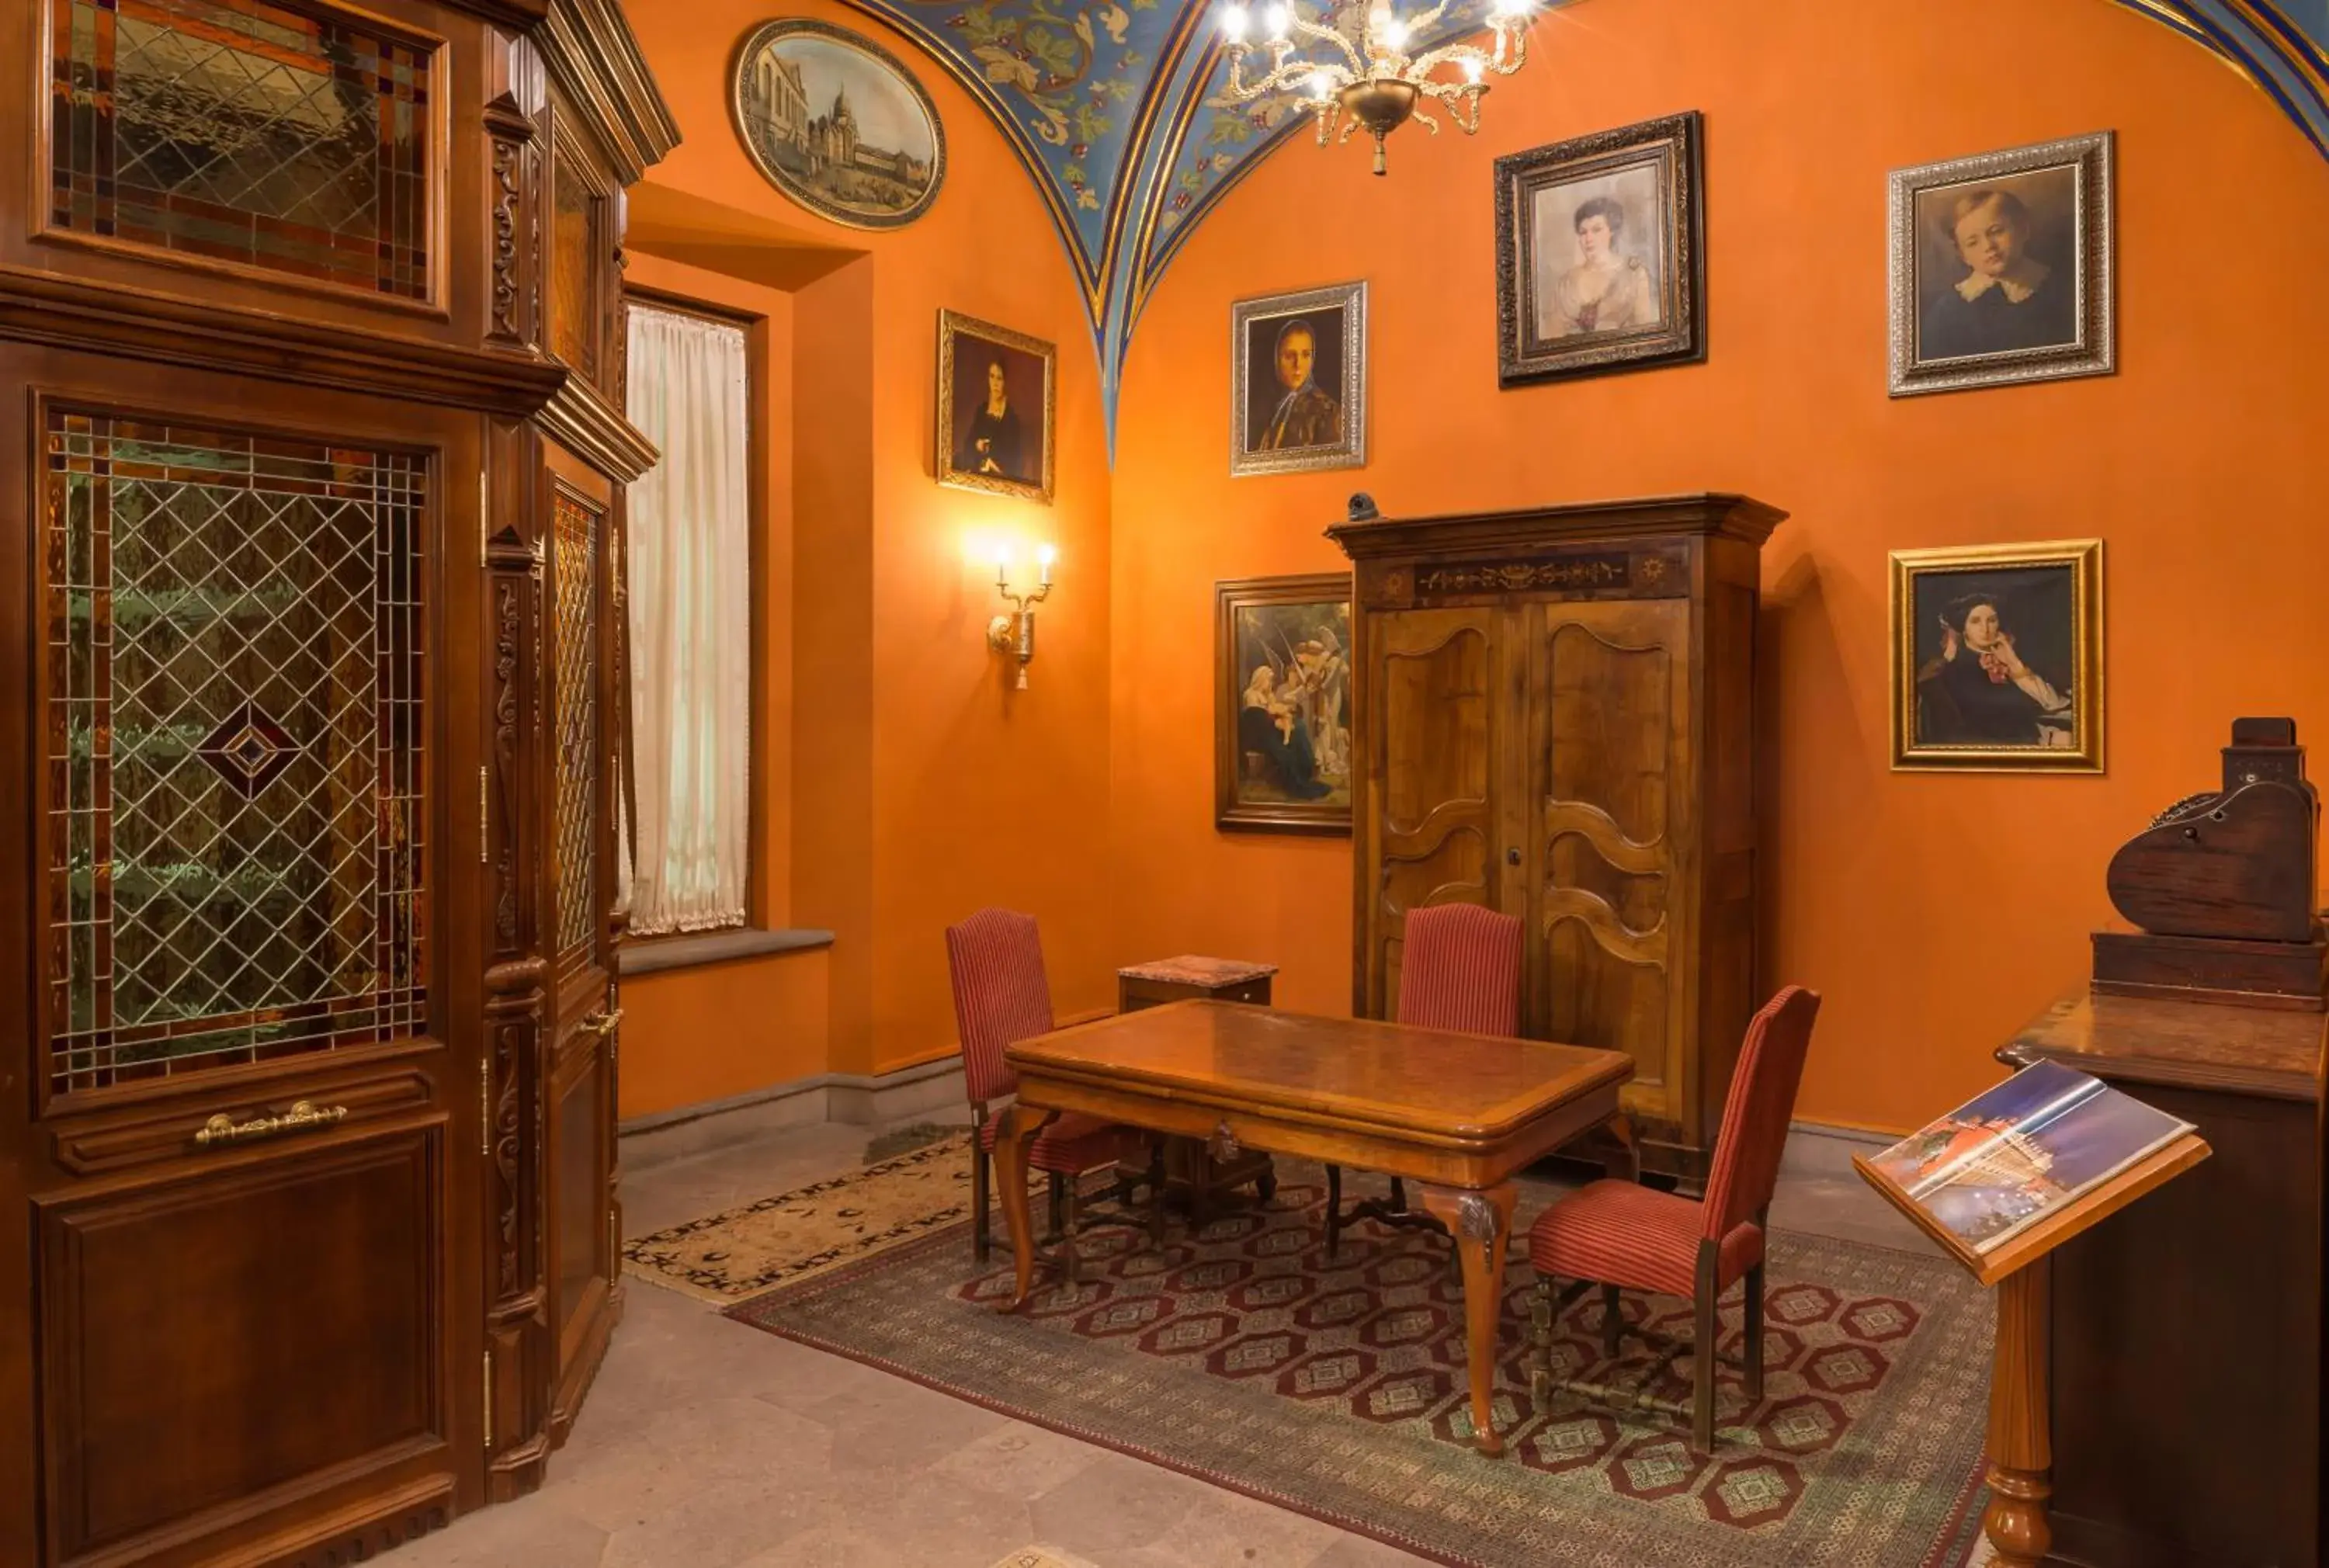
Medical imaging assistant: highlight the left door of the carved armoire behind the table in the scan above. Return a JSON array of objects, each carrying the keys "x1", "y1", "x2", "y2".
[{"x1": 1355, "y1": 608, "x2": 1519, "y2": 1018}]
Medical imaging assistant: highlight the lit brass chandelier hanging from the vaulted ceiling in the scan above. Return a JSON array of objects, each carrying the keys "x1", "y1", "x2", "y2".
[{"x1": 1220, "y1": 0, "x2": 1532, "y2": 175}]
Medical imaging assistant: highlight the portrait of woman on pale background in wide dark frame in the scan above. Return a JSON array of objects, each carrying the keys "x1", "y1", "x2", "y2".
[{"x1": 1495, "y1": 109, "x2": 1707, "y2": 387}]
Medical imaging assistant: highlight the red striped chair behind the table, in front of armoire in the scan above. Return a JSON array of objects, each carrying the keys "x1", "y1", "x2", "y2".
[{"x1": 1325, "y1": 904, "x2": 1521, "y2": 1258}]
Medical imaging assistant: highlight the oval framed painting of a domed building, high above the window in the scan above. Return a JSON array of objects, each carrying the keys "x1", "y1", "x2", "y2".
[{"x1": 729, "y1": 16, "x2": 946, "y2": 228}]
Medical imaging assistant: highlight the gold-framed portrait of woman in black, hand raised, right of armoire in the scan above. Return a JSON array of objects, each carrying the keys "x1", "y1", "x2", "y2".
[{"x1": 1891, "y1": 538, "x2": 2103, "y2": 773}]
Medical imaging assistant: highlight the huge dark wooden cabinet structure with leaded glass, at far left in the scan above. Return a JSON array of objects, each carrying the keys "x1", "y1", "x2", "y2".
[{"x1": 0, "y1": 0, "x2": 678, "y2": 1568}]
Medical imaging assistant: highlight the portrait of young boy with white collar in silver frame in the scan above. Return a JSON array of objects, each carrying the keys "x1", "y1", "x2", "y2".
[{"x1": 1891, "y1": 130, "x2": 2117, "y2": 398}]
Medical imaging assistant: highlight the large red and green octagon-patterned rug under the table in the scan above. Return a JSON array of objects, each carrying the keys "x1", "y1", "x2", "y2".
[{"x1": 729, "y1": 1160, "x2": 1991, "y2": 1568}]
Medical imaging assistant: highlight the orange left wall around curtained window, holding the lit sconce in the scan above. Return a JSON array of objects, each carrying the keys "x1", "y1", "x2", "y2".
[{"x1": 624, "y1": 0, "x2": 1113, "y2": 1116}]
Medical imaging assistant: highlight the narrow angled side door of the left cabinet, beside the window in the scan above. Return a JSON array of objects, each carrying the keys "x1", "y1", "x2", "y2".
[{"x1": 543, "y1": 447, "x2": 622, "y2": 1442}]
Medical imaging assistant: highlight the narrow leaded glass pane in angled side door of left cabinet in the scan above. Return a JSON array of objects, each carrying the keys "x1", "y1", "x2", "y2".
[{"x1": 552, "y1": 489, "x2": 601, "y2": 953}]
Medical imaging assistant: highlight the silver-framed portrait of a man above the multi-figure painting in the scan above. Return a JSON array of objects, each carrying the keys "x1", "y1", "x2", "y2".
[{"x1": 1230, "y1": 282, "x2": 1367, "y2": 475}]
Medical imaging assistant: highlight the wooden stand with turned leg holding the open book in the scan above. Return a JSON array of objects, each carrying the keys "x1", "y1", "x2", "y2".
[{"x1": 1852, "y1": 1133, "x2": 2210, "y2": 1568}]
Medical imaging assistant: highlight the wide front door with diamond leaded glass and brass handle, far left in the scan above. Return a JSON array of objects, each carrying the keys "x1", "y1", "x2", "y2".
[{"x1": 0, "y1": 347, "x2": 482, "y2": 1566}]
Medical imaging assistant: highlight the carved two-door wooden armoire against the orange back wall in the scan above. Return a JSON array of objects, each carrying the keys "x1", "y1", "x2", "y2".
[{"x1": 1328, "y1": 496, "x2": 1784, "y2": 1184}]
